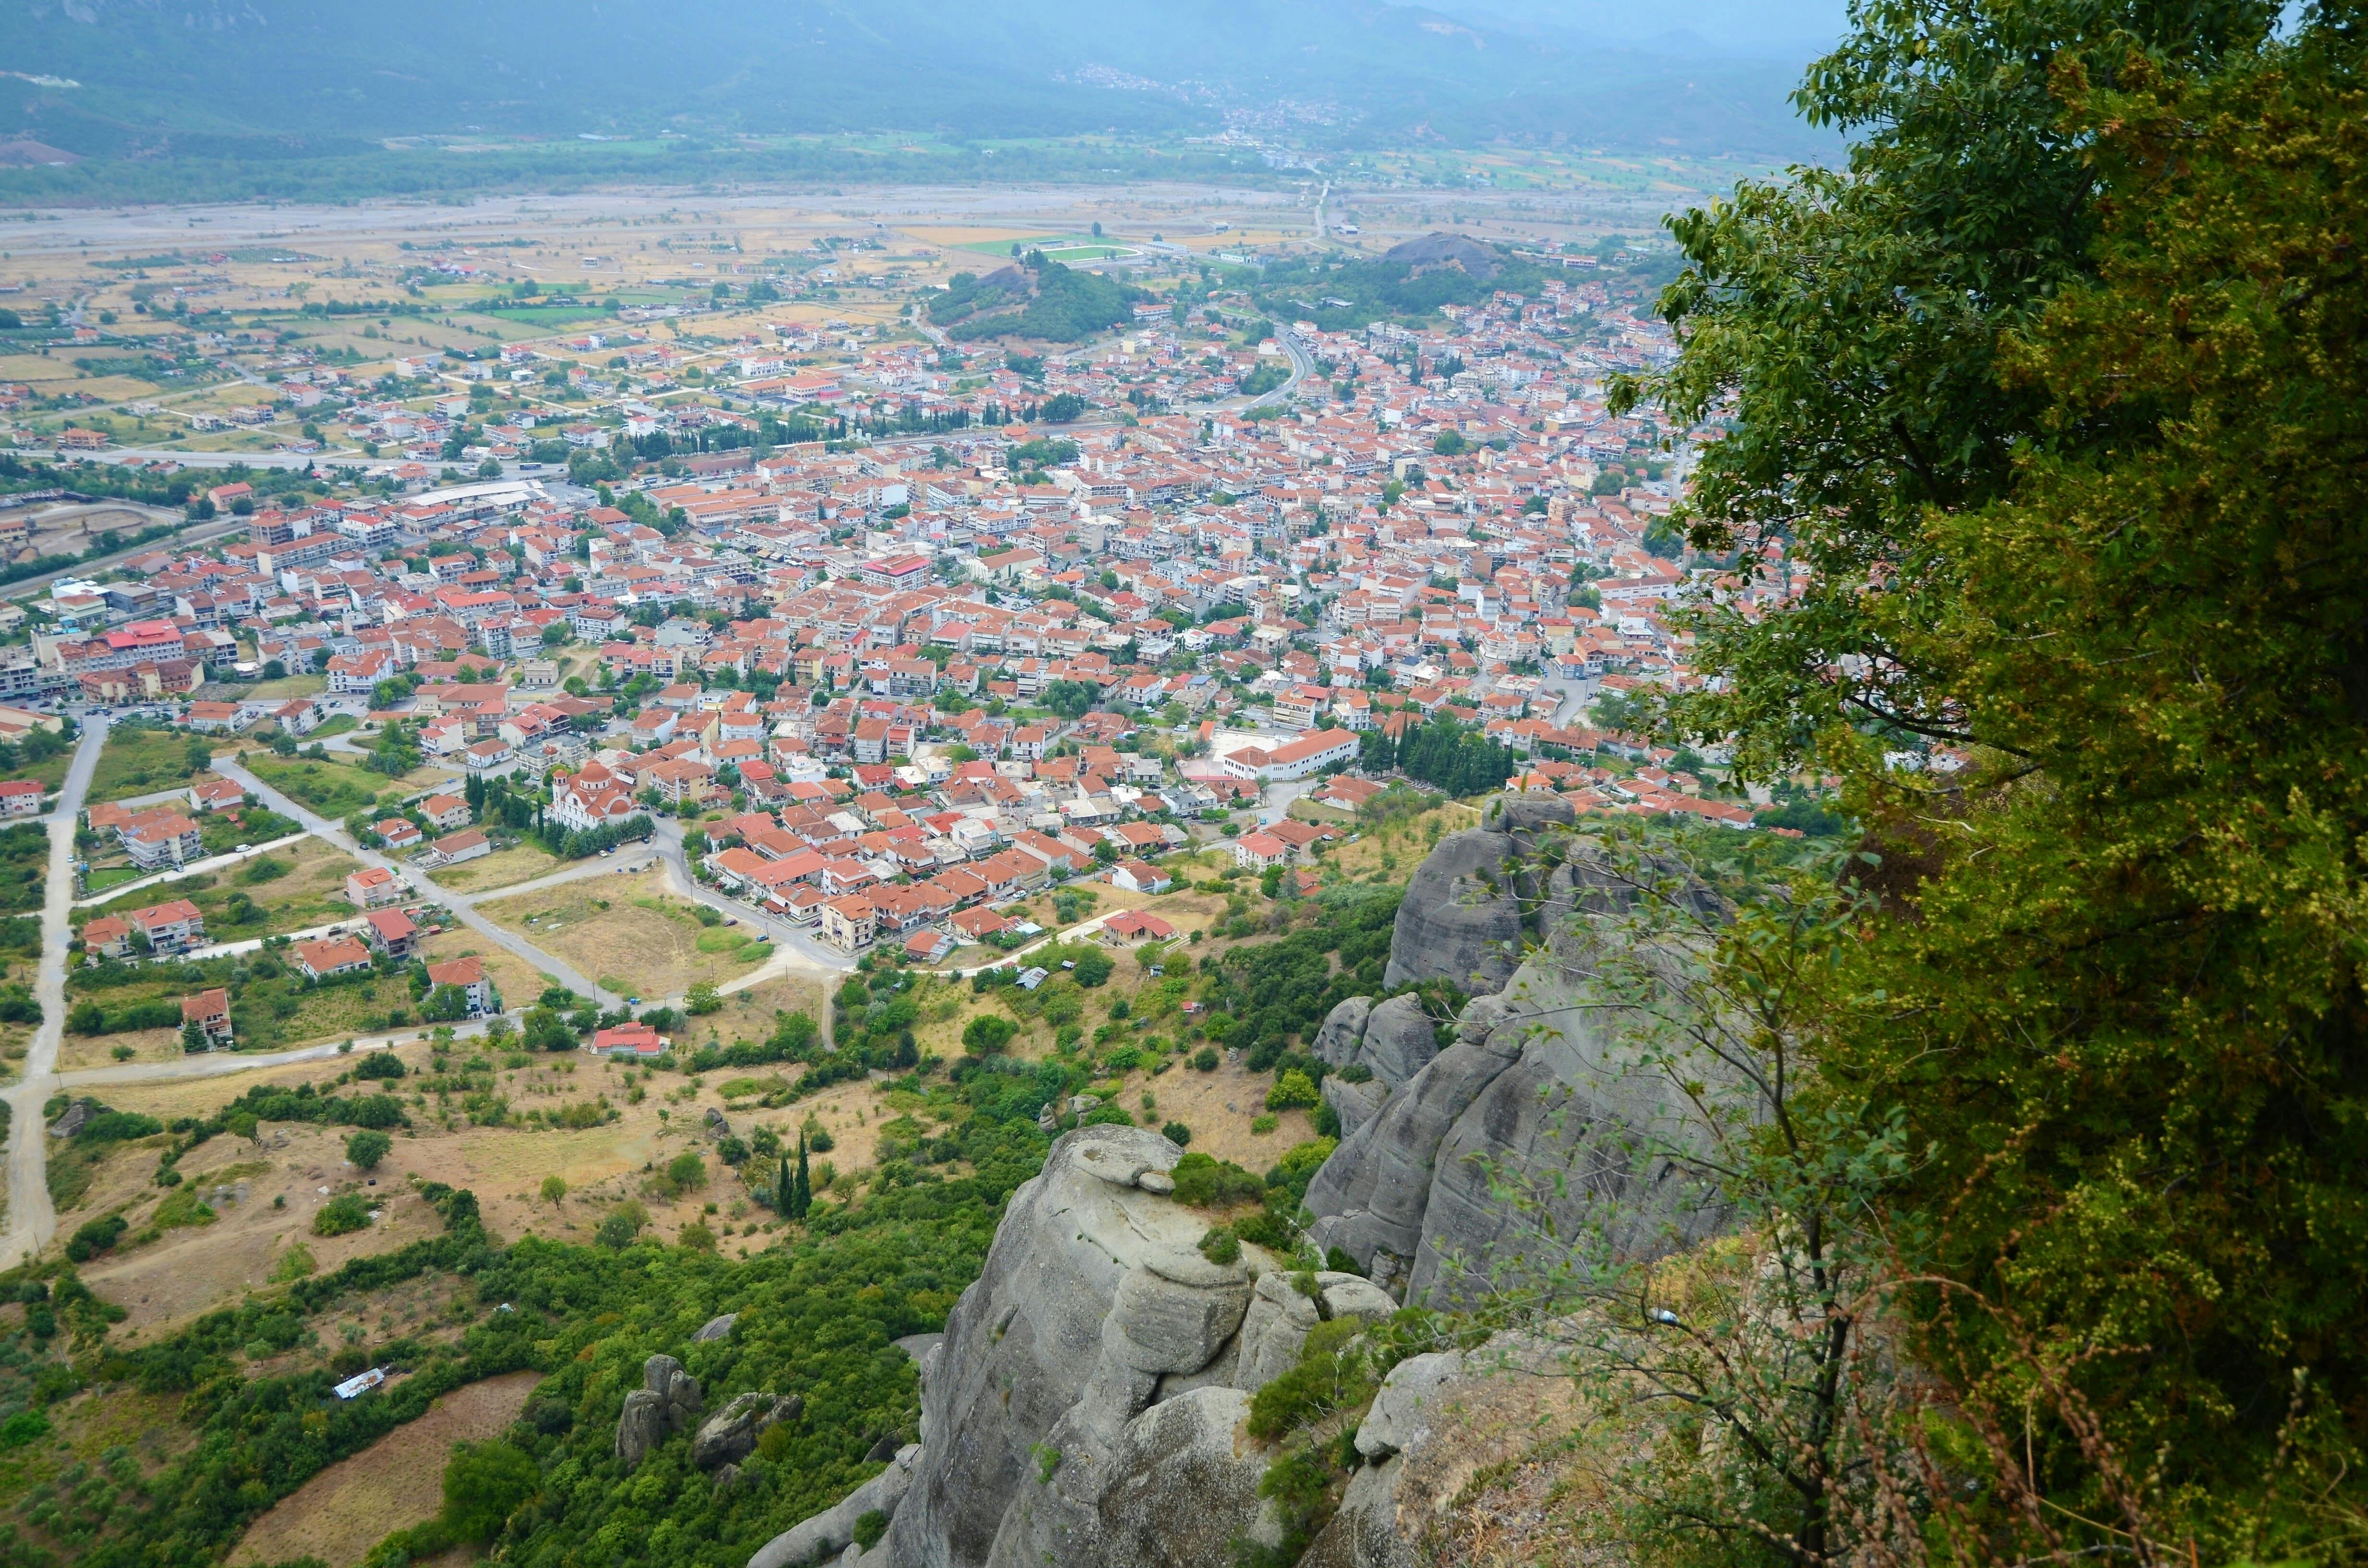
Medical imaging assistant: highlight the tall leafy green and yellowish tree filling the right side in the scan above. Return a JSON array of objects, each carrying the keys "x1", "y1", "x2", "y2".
[{"x1": 1601, "y1": 0, "x2": 2368, "y2": 1563}]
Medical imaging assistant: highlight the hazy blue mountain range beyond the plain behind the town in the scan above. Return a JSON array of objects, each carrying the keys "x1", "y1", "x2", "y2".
[{"x1": 0, "y1": 0, "x2": 1797, "y2": 156}]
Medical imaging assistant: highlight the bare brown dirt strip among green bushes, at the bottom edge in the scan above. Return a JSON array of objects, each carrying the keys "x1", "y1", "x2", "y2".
[{"x1": 227, "y1": 1372, "x2": 543, "y2": 1568}]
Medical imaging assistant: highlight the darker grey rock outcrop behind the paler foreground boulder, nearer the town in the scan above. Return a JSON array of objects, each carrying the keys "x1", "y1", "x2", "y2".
[{"x1": 1307, "y1": 796, "x2": 1724, "y2": 1300}]
